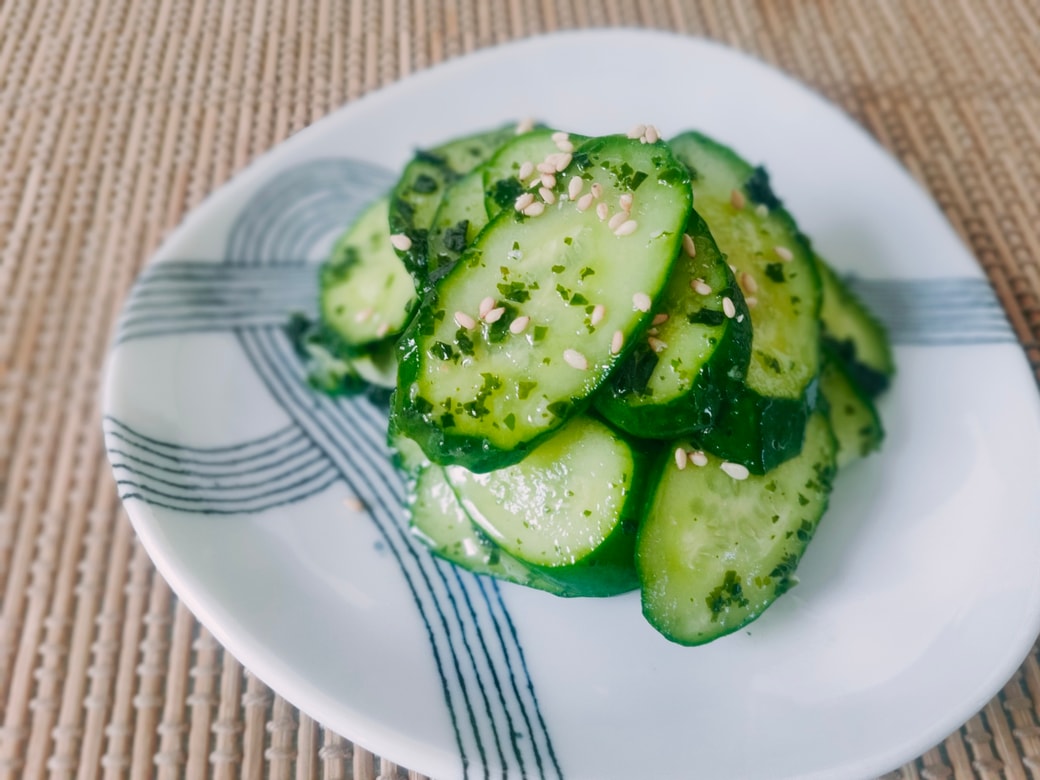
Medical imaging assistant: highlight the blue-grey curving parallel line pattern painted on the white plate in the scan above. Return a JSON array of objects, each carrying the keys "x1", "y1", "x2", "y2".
[{"x1": 105, "y1": 159, "x2": 1016, "y2": 780}]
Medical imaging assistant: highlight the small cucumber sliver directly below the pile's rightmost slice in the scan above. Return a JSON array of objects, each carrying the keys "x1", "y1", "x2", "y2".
[{"x1": 820, "y1": 344, "x2": 885, "y2": 469}]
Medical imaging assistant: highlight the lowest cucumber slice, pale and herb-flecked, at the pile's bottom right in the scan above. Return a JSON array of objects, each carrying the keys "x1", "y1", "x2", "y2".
[{"x1": 635, "y1": 412, "x2": 835, "y2": 645}]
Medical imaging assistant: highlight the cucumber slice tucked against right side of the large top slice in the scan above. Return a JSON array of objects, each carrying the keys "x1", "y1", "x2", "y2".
[{"x1": 596, "y1": 210, "x2": 751, "y2": 439}]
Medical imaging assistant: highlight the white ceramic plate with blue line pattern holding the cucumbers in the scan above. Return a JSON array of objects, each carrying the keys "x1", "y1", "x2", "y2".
[{"x1": 104, "y1": 31, "x2": 1040, "y2": 780}]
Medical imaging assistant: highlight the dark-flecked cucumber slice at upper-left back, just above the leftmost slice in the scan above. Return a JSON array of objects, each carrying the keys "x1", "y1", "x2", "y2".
[{"x1": 389, "y1": 125, "x2": 517, "y2": 290}]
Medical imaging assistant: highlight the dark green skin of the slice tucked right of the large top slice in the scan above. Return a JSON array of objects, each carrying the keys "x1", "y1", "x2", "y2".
[{"x1": 596, "y1": 210, "x2": 757, "y2": 446}]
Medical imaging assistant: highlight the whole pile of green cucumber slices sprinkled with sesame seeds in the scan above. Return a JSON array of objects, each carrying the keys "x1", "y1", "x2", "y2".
[{"x1": 293, "y1": 125, "x2": 893, "y2": 645}]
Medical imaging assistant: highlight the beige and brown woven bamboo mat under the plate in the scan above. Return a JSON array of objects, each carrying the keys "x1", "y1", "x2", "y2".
[{"x1": 0, "y1": 0, "x2": 1040, "y2": 780}]
